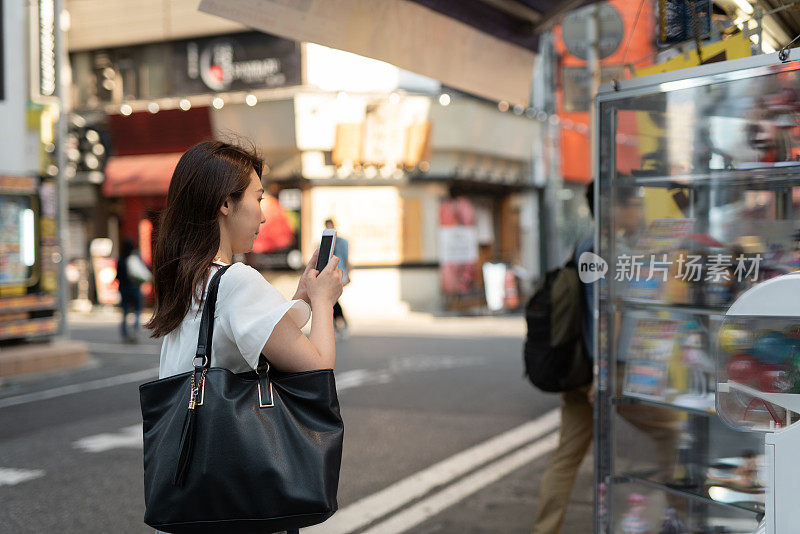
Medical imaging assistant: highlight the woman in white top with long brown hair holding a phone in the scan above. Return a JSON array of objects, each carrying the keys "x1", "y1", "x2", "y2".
[{"x1": 146, "y1": 141, "x2": 342, "y2": 532}]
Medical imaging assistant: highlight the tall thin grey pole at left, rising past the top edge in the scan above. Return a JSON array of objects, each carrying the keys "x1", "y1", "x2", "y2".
[{"x1": 54, "y1": 0, "x2": 70, "y2": 337}]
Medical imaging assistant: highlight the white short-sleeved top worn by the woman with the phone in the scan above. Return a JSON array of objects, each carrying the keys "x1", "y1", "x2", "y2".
[{"x1": 158, "y1": 263, "x2": 311, "y2": 378}]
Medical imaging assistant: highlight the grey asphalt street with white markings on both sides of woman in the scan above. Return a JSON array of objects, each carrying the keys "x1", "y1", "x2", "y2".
[{"x1": 0, "y1": 312, "x2": 592, "y2": 534}]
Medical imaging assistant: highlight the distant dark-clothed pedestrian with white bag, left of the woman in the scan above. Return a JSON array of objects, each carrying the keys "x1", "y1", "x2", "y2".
[{"x1": 117, "y1": 239, "x2": 152, "y2": 343}]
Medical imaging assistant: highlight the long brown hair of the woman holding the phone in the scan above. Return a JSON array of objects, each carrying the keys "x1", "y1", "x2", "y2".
[{"x1": 145, "y1": 141, "x2": 263, "y2": 337}]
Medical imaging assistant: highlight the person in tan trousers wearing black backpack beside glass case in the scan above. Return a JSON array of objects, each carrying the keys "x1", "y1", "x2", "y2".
[{"x1": 525, "y1": 182, "x2": 597, "y2": 534}]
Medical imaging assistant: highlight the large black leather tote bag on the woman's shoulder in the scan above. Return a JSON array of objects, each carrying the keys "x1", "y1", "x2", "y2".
[{"x1": 139, "y1": 267, "x2": 344, "y2": 534}]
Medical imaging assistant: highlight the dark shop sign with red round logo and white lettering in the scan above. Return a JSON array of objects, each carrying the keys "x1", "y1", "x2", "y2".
[{"x1": 173, "y1": 33, "x2": 301, "y2": 95}]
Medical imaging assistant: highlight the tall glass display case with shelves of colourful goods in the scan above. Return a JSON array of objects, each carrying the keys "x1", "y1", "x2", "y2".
[{"x1": 594, "y1": 51, "x2": 800, "y2": 533}]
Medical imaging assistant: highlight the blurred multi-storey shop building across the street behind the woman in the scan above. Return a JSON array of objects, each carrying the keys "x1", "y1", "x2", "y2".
[{"x1": 68, "y1": 2, "x2": 540, "y2": 316}]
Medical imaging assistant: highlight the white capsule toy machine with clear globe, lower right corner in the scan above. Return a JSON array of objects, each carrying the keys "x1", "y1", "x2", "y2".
[{"x1": 717, "y1": 273, "x2": 800, "y2": 534}]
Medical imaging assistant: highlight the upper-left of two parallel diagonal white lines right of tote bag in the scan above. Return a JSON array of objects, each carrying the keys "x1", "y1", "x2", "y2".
[{"x1": 303, "y1": 408, "x2": 561, "y2": 534}]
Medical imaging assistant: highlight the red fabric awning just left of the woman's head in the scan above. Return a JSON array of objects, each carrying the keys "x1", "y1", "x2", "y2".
[{"x1": 103, "y1": 152, "x2": 182, "y2": 197}]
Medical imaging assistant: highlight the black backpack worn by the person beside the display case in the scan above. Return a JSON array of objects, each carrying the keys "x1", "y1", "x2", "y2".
[{"x1": 523, "y1": 257, "x2": 592, "y2": 392}]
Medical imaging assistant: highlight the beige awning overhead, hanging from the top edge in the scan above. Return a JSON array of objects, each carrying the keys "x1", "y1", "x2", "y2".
[{"x1": 199, "y1": 0, "x2": 588, "y2": 105}]
